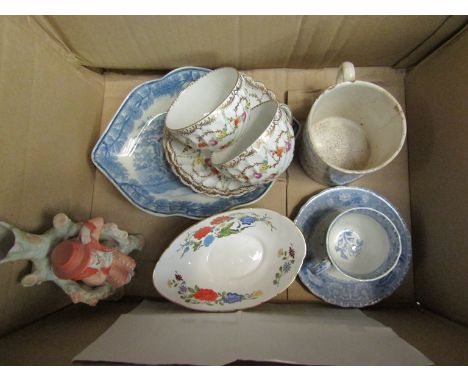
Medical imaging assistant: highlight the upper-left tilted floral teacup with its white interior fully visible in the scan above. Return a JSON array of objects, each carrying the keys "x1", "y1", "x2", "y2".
[{"x1": 165, "y1": 68, "x2": 251, "y2": 151}]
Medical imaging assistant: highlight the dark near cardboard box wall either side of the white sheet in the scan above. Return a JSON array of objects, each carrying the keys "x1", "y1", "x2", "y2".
[{"x1": 0, "y1": 301, "x2": 468, "y2": 365}]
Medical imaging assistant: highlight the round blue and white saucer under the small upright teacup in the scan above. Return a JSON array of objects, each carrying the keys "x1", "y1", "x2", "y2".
[{"x1": 294, "y1": 187, "x2": 412, "y2": 308}]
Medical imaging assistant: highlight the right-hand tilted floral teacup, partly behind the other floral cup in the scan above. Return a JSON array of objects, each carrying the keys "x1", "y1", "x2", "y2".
[{"x1": 211, "y1": 100, "x2": 294, "y2": 185}]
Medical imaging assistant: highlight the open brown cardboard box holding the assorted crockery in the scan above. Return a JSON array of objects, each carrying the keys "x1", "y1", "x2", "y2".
[{"x1": 0, "y1": 16, "x2": 468, "y2": 364}]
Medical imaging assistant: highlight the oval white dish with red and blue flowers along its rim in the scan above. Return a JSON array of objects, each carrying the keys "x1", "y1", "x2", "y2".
[{"x1": 153, "y1": 208, "x2": 306, "y2": 312}]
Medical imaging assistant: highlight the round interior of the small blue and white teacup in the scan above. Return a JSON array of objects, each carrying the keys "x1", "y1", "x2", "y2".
[{"x1": 326, "y1": 207, "x2": 401, "y2": 281}]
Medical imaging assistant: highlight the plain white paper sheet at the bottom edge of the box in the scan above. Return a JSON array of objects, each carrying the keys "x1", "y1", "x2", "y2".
[{"x1": 74, "y1": 301, "x2": 432, "y2": 365}]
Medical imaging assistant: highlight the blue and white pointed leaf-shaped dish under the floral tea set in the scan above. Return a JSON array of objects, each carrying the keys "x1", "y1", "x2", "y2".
[{"x1": 91, "y1": 67, "x2": 271, "y2": 219}]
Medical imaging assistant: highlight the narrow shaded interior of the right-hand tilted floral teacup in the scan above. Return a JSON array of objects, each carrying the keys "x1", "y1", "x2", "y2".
[{"x1": 211, "y1": 100, "x2": 278, "y2": 166}]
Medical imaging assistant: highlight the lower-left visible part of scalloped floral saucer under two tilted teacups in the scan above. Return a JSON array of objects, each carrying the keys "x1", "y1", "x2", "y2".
[{"x1": 164, "y1": 131, "x2": 258, "y2": 198}]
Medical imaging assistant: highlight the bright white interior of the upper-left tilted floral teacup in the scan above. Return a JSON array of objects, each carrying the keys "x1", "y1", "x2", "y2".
[{"x1": 166, "y1": 68, "x2": 239, "y2": 130}]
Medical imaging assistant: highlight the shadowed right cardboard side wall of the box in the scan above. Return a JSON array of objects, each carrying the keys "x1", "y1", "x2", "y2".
[{"x1": 406, "y1": 27, "x2": 468, "y2": 324}]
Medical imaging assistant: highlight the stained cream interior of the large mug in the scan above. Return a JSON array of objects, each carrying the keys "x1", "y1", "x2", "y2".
[{"x1": 307, "y1": 81, "x2": 406, "y2": 172}]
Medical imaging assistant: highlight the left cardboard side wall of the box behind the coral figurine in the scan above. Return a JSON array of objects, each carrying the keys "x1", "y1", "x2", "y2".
[{"x1": 0, "y1": 17, "x2": 104, "y2": 334}]
